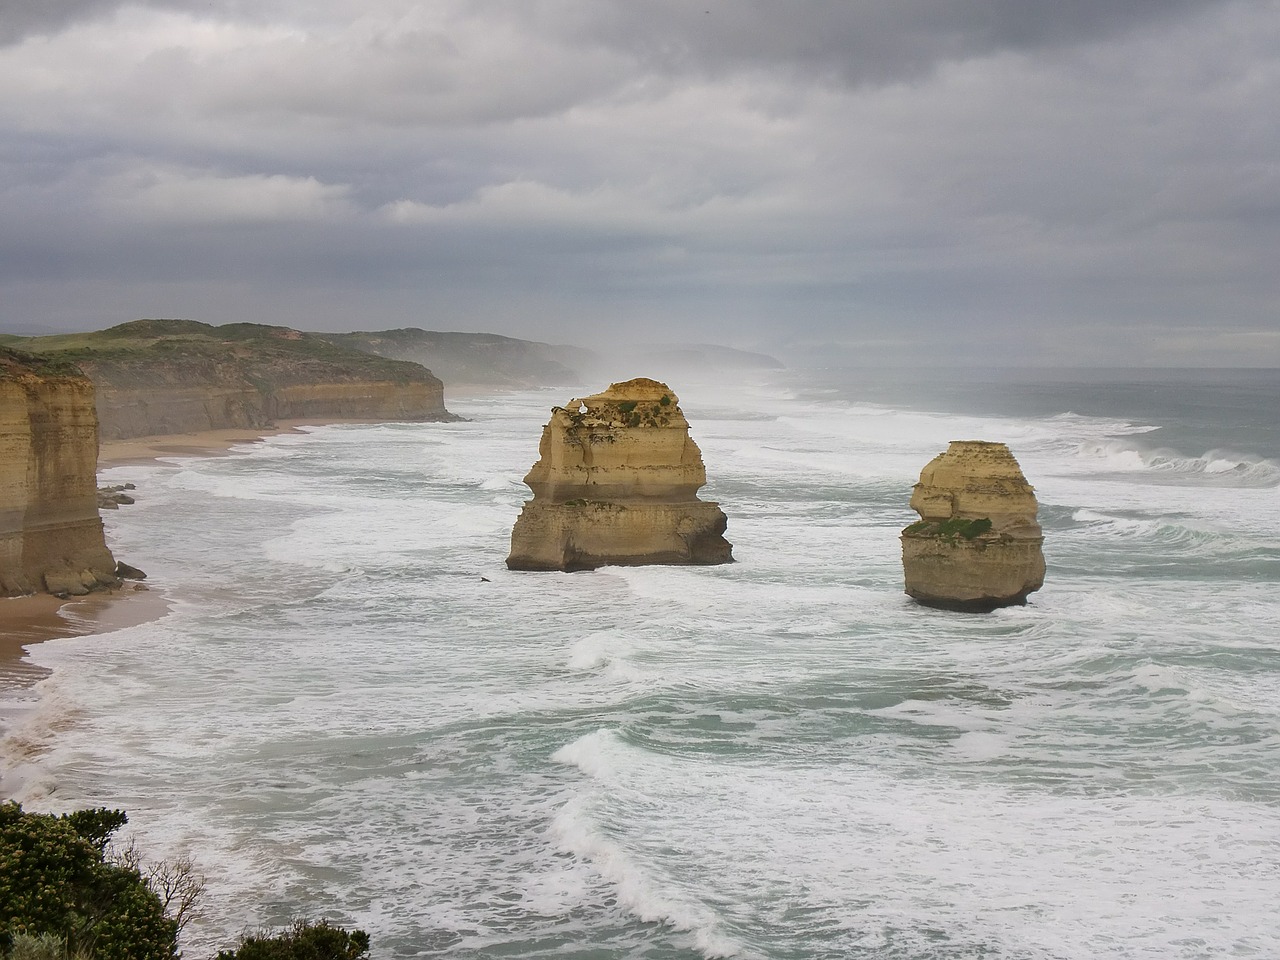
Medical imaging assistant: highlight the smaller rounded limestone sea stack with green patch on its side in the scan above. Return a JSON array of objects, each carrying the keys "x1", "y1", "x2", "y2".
[{"x1": 902, "y1": 440, "x2": 1044, "y2": 612}]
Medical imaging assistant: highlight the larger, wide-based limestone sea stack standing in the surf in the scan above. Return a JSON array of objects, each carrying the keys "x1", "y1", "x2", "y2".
[{"x1": 507, "y1": 378, "x2": 733, "y2": 571}]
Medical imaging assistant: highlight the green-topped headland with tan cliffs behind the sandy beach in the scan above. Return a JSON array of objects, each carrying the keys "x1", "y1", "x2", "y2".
[{"x1": 3, "y1": 320, "x2": 453, "y2": 440}]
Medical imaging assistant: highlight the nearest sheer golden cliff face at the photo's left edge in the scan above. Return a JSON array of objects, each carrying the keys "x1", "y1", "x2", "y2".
[{"x1": 0, "y1": 348, "x2": 119, "y2": 596}]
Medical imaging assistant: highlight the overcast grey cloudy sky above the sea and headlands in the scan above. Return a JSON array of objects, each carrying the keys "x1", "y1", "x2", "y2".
[{"x1": 0, "y1": 0, "x2": 1280, "y2": 366}]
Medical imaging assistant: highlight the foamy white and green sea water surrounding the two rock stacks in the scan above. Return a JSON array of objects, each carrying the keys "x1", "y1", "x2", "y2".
[{"x1": 4, "y1": 371, "x2": 1280, "y2": 960}]
